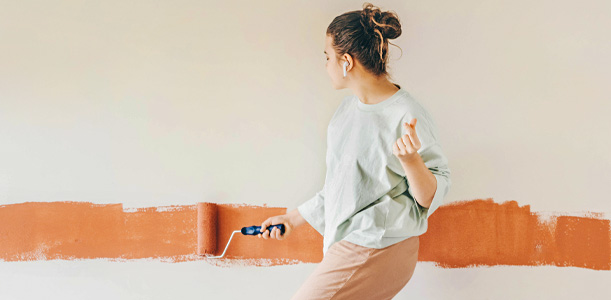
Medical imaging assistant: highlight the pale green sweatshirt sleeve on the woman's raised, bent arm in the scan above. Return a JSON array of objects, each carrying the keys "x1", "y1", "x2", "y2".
[{"x1": 401, "y1": 112, "x2": 452, "y2": 219}]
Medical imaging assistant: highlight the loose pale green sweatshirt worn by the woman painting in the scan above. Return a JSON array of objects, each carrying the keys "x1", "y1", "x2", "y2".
[{"x1": 297, "y1": 89, "x2": 451, "y2": 255}]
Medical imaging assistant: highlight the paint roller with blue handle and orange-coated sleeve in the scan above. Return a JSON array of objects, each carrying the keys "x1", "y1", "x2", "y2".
[{"x1": 197, "y1": 202, "x2": 285, "y2": 258}]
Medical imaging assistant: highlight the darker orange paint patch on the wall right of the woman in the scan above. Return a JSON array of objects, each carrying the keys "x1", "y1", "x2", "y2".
[{"x1": 418, "y1": 199, "x2": 611, "y2": 270}]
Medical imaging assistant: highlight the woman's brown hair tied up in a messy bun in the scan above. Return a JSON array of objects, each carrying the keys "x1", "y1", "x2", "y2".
[{"x1": 327, "y1": 2, "x2": 403, "y2": 88}]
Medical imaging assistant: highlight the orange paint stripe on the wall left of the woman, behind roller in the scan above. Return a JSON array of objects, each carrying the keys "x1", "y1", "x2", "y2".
[{"x1": 0, "y1": 202, "x2": 322, "y2": 265}]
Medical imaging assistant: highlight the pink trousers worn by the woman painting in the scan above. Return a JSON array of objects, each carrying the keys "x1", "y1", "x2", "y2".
[{"x1": 291, "y1": 236, "x2": 420, "y2": 300}]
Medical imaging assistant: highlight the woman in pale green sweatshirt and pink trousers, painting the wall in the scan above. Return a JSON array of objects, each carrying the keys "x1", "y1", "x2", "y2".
[{"x1": 258, "y1": 3, "x2": 451, "y2": 300}]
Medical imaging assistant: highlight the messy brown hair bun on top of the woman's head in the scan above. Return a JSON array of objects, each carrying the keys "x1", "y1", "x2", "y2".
[{"x1": 361, "y1": 2, "x2": 401, "y2": 39}]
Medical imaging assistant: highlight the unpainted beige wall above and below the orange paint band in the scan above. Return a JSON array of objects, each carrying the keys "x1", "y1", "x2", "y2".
[{"x1": 0, "y1": 0, "x2": 611, "y2": 299}]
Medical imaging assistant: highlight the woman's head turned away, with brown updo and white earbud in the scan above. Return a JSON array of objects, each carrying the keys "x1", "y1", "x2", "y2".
[{"x1": 325, "y1": 2, "x2": 401, "y2": 89}]
